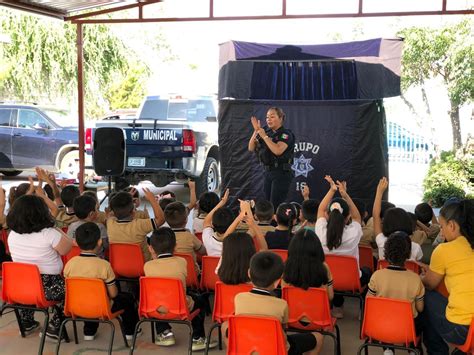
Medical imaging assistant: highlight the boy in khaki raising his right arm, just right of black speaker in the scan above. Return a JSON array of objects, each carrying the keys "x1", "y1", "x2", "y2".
[{"x1": 107, "y1": 189, "x2": 165, "y2": 261}]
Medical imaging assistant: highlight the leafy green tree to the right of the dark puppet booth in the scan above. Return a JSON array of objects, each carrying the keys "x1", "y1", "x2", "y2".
[{"x1": 398, "y1": 20, "x2": 474, "y2": 150}]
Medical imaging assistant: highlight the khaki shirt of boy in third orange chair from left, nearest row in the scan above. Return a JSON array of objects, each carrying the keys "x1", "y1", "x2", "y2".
[{"x1": 144, "y1": 254, "x2": 194, "y2": 310}]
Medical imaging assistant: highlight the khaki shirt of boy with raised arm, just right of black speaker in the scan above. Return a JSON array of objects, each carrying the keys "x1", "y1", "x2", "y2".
[{"x1": 107, "y1": 218, "x2": 157, "y2": 261}]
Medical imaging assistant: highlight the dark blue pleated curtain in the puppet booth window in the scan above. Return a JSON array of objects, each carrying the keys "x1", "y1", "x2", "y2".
[{"x1": 250, "y1": 61, "x2": 357, "y2": 100}]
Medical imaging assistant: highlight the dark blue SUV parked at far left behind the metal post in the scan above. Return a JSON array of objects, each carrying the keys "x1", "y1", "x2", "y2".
[{"x1": 0, "y1": 103, "x2": 86, "y2": 178}]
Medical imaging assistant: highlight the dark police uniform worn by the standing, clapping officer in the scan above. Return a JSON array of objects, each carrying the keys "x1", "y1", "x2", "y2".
[{"x1": 256, "y1": 126, "x2": 295, "y2": 209}]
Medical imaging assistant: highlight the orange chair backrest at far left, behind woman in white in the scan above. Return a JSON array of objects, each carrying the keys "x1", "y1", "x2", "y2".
[{"x1": 2, "y1": 261, "x2": 51, "y2": 308}]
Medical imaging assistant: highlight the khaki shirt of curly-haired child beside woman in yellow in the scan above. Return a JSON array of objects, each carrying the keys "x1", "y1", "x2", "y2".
[{"x1": 368, "y1": 266, "x2": 425, "y2": 318}]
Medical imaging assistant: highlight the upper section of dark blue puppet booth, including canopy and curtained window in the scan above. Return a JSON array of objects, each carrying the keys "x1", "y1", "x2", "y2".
[{"x1": 218, "y1": 38, "x2": 403, "y2": 100}]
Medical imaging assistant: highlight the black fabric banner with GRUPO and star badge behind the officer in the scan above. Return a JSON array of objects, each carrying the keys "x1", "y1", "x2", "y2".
[{"x1": 218, "y1": 100, "x2": 388, "y2": 208}]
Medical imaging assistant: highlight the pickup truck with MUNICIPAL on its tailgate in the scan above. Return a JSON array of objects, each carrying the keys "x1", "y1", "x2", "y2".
[{"x1": 85, "y1": 95, "x2": 221, "y2": 194}]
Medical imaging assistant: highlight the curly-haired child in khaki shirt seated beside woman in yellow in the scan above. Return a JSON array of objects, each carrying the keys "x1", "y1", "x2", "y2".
[{"x1": 367, "y1": 232, "x2": 425, "y2": 340}]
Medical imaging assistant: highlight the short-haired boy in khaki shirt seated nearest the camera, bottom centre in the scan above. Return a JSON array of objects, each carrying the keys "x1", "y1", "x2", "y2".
[{"x1": 228, "y1": 251, "x2": 323, "y2": 354}]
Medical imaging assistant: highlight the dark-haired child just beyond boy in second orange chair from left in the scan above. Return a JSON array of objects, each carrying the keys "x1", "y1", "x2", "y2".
[{"x1": 67, "y1": 194, "x2": 109, "y2": 258}]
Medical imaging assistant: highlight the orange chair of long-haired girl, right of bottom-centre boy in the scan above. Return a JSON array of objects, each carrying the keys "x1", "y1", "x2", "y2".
[{"x1": 281, "y1": 286, "x2": 341, "y2": 355}]
